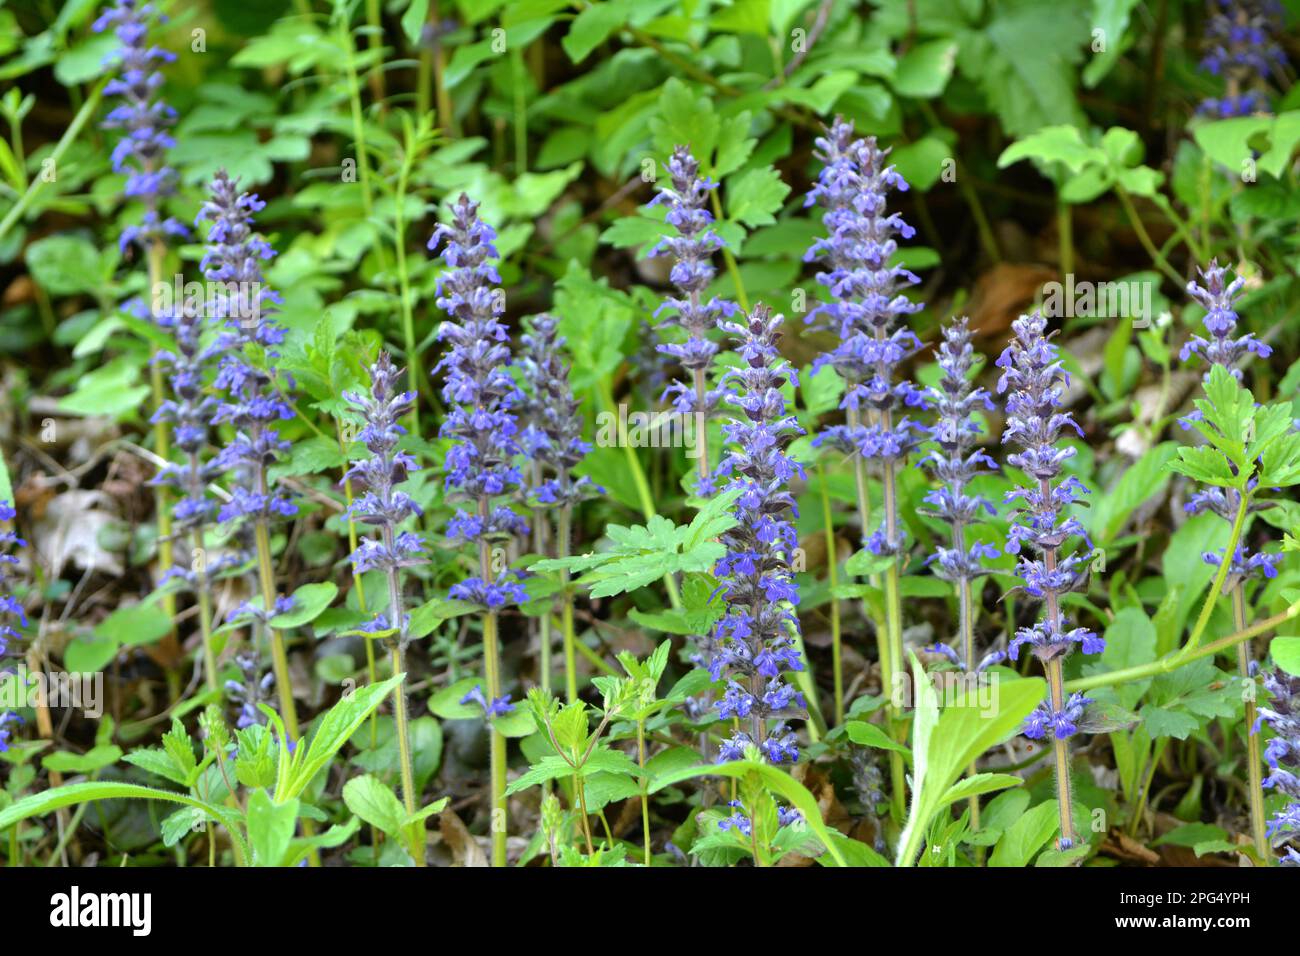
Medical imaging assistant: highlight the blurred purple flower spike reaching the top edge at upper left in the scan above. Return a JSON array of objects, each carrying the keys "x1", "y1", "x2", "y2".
[{"x1": 94, "y1": 0, "x2": 189, "y2": 252}]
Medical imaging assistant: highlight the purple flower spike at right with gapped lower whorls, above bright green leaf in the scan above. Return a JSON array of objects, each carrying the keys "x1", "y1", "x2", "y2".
[{"x1": 997, "y1": 312, "x2": 1105, "y2": 740}]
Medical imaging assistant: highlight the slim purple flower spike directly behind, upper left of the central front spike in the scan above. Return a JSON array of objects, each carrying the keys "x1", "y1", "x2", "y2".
[{"x1": 649, "y1": 146, "x2": 737, "y2": 418}]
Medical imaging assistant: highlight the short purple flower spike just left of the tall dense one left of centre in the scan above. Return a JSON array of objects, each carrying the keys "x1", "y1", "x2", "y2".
[{"x1": 343, "y1": 352, "x2": 426, "y2": 644}]
